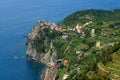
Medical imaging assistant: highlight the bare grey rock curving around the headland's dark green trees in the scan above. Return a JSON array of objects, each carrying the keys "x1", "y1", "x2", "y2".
[{"x1": 26, "y1": 20, "x2": 60, "y2": 65}]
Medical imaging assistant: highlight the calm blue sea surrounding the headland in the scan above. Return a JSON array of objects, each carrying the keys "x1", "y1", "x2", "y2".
[{"x1": 0, "y1": 0, "x2": 120, "y2": 80}]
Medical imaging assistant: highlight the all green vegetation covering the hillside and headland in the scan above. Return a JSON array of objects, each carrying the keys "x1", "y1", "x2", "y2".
[{"x1": 33, "y1": 9, "x2": 120, "y2": 80}]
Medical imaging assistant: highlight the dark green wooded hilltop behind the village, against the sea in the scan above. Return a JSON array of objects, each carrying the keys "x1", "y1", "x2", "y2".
[{"x1": 59, "y1": 9, "x2": 120, "y2": 27}]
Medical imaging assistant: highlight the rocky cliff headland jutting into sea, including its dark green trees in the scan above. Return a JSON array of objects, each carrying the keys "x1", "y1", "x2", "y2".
[{"x1": 26, "y1": 20, "x2": 60, "y2": 65}]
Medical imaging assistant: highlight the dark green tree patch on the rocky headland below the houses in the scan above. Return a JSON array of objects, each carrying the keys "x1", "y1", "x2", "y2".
[{"x1": 32, "y1": 28, "x2": 62, "y2": 53}]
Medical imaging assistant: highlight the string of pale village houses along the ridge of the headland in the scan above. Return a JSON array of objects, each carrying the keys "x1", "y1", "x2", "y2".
[{"x1": 38, "y1": 20, "x2": 95, "y2": 39}]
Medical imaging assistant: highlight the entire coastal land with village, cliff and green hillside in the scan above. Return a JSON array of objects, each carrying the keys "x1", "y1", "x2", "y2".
[{"x1": 27, "y1": 10, "x2": 120, "y2": 80}]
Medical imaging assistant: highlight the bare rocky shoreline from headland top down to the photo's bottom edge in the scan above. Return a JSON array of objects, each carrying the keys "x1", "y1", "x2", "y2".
[{"x1": 26, "y1": 20, "x2": 61, "y2": 80}]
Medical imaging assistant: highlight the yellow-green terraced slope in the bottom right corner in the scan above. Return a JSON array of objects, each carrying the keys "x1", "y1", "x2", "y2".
[{"x1": 98, "y1": 49, "x2": 120, "y2": 80}]
